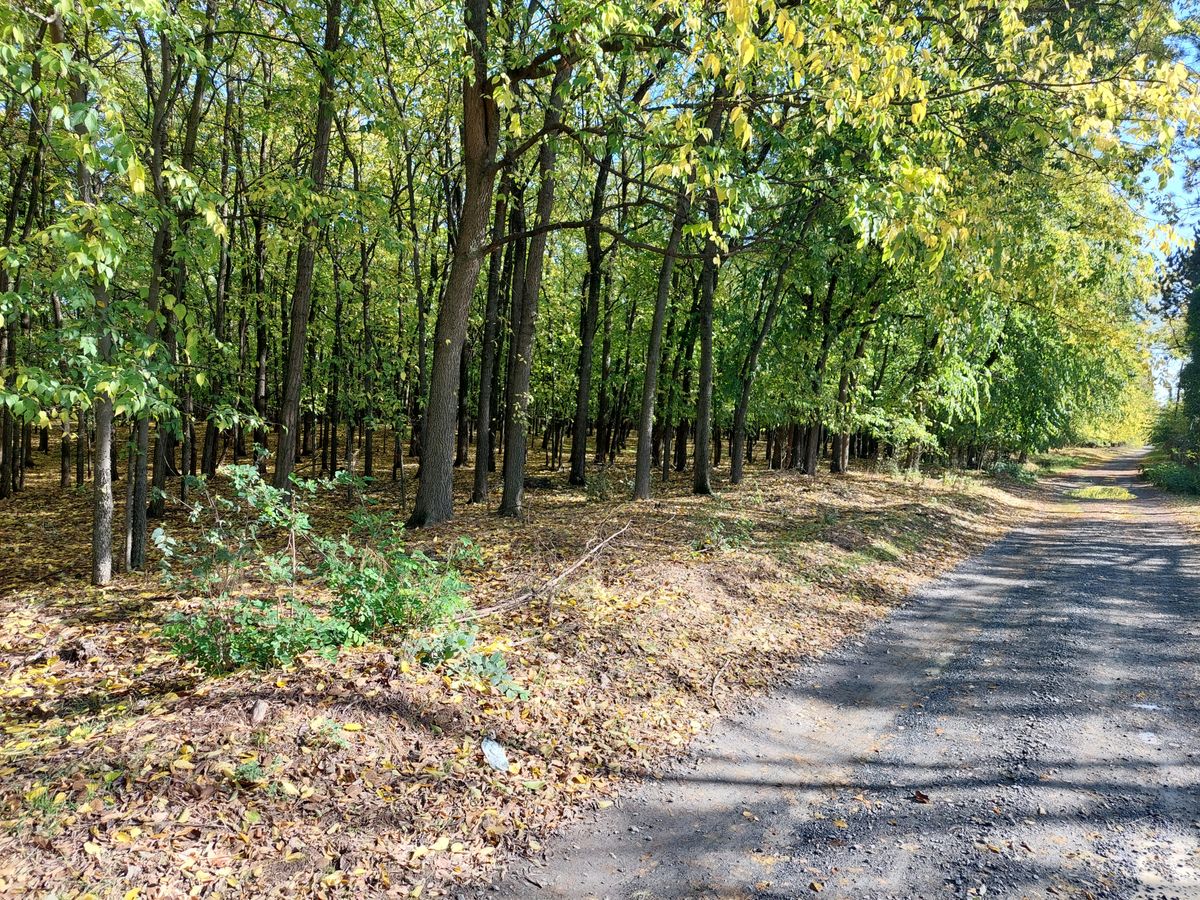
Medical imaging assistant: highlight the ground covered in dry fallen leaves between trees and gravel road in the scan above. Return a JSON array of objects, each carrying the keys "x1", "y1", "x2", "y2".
[{"x1": 0, "y1": 448, "x2": 1096, "y2": 898}]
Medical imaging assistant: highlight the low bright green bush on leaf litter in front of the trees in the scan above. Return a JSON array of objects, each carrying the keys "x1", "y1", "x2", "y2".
[{"x1": 154, "y1": 466, "x2": 480, "y2": 673}]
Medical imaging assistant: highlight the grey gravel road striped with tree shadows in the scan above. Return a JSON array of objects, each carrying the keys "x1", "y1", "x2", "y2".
[{"x1": 485, "y1": 454, "x2": 1200, "y2": 900}]
